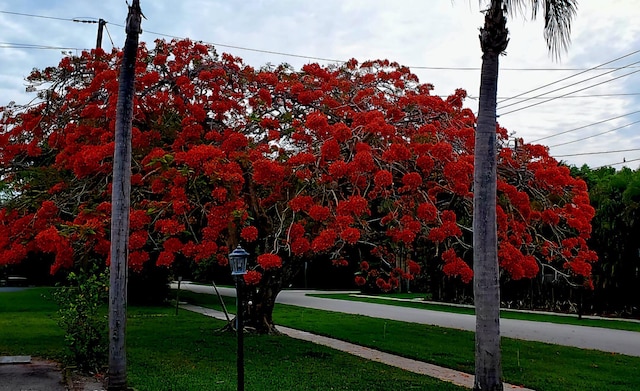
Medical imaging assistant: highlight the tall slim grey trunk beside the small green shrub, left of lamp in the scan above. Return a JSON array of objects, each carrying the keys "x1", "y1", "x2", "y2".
[{"x1": 108, "y1": 0, "x2": 143, "y2": 391}]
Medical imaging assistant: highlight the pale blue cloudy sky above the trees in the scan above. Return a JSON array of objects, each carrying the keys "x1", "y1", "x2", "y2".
[{"x1": 0, "y1": 0, "x2": 640, "y2": 169}]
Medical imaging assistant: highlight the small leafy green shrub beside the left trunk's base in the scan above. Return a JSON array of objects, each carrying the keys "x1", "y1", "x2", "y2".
[{"x1": 53, "y1": 266, "x2": 109, "y2": 372}]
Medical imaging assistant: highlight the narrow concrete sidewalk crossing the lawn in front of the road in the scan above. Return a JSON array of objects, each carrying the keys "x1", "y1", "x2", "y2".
[{"x1": 180, "y1": 304, "x2": 533, "y2": 391}]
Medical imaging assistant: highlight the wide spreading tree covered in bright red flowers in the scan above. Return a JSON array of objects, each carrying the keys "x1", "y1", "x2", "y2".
[{"x1": 0, "y1": 40, "x2": 596, "y2": 332}]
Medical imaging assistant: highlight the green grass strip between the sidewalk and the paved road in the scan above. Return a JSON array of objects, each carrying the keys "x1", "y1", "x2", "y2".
[{"x1": 176, "y1": 292, "x2": 640, "y2": 391}]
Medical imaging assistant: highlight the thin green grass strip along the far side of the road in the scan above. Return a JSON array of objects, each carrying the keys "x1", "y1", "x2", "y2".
[{"x1": 310, "y1": 293, "x2": 640, "y2": 332}]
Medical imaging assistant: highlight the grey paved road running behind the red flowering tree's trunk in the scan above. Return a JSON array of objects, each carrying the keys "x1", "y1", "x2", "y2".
[{"x1": 173, "y1": 283, "x2": 640, "y2": 357}]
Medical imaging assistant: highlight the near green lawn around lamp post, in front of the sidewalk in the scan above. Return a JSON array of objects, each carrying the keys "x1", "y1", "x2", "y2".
[{"x1": 0, "y1": 288, "x2": 462, "y2": 391}]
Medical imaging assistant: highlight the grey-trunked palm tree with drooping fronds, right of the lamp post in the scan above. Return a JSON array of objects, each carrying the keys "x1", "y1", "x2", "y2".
[{"x1": 473, "y1": 0, "x2": 577, "y2": 391}]
